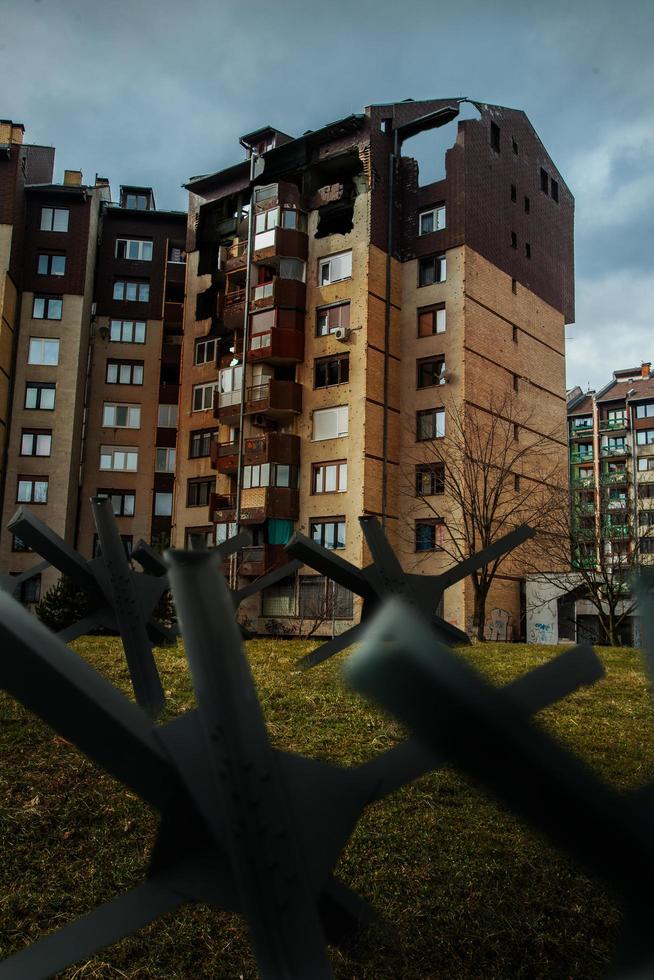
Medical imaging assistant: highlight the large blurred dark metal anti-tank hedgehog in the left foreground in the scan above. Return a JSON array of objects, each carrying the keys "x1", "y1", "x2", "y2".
[{"x1": 0, "y1": 524, "x2": 601, "y2": 980}]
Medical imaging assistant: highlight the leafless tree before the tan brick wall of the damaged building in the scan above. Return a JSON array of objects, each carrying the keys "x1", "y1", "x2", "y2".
[{"x1": 400, "y1": 393, "x2": 566, "y2": 640}]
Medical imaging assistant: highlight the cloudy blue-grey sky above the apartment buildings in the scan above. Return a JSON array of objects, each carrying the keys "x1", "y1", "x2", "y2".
[{"x1": 0, "y1": 0, "x2": 654, "y2": 388}]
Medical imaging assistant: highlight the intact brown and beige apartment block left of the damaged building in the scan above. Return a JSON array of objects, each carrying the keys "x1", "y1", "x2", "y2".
[{"x1": 0, "y1": 124, "x2": 186, "y2": 601}]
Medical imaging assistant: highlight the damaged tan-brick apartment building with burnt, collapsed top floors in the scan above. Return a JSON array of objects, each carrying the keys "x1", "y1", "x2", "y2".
[{"x1": 172, "y1": 99, "x2": 574, "y2": 639}]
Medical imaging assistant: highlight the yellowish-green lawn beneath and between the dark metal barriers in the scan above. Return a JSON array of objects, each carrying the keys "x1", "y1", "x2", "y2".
[{"x1": 0, "y1": 638, "x2": 654, "y2": 980}]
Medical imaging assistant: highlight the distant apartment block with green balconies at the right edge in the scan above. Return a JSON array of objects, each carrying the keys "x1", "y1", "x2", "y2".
[{"x1": 568, "y1": 361, "x2": 654, "y2": 568}]
